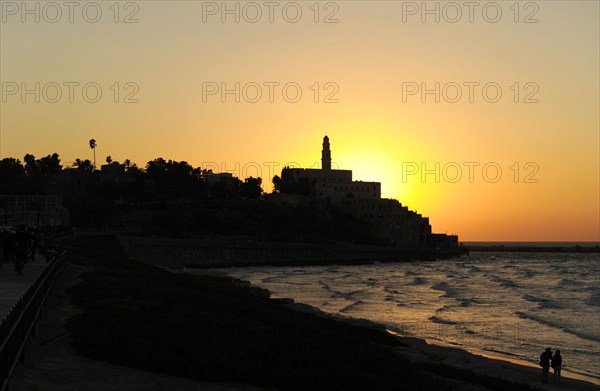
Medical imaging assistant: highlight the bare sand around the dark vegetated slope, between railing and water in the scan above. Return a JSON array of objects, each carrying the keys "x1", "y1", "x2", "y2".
[{"x1": 5, "y1": 237, "x2": 599, "y2": 390}]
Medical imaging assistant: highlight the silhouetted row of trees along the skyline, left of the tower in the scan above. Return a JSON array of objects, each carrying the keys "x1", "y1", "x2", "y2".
[{"x1": 0, "y1": 153, "x2": 263, "y2": 203}]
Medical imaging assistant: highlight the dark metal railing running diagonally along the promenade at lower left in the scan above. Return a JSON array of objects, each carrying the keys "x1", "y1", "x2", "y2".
[{"x1": 0, "y1": 252, "x2": 65, "y2": 391}]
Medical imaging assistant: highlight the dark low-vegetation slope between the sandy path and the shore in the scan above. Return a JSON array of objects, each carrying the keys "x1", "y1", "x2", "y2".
[{"x1": 65, "y1": 238, "x2": 526, "y2": 390}]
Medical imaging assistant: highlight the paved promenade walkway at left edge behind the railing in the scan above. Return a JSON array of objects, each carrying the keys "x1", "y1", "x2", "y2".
[{"x1": 0, "y1": 254, "x2": 47, "y2": 319}]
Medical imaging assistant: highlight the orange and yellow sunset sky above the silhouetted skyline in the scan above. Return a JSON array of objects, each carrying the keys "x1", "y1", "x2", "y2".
[{"x1": 0, "y1": 0, "x2": 600, "y2": 241}]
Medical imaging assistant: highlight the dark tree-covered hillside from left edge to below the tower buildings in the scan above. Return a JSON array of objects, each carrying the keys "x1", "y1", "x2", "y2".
[{"x1": 0, "y1": 153, "x2": 375, "y2": 243}]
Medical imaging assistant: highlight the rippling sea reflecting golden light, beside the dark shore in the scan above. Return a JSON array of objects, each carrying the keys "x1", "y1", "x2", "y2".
[{"x1": 221, "y1": 250, "x2": 600, "y2": 383}]
